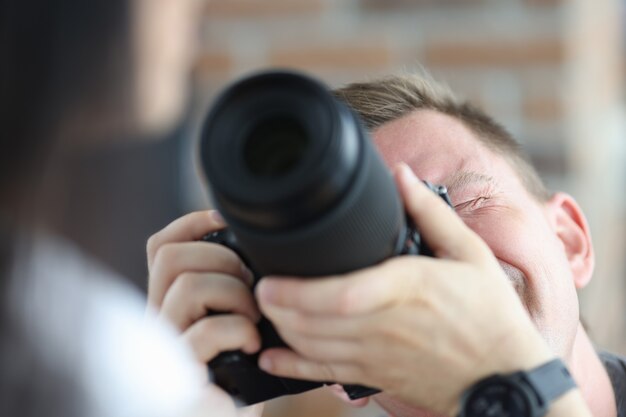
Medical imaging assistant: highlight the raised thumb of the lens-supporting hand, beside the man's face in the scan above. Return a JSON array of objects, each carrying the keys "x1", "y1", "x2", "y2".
[{"x1": 395, "y1": 164, "x2": 490, "y2": 262}]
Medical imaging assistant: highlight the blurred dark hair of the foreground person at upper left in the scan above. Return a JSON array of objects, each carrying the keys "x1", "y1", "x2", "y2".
[{"x1": 0, "y1": 0, "x2": 132, "y2": 270}]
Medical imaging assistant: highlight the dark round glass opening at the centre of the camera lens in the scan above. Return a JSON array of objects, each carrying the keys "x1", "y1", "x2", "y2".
[{"x1": 243, "y1": 115, "x2": 310, "y2": 178}]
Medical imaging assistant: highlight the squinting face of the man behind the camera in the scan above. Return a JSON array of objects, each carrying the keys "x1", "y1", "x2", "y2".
[{"x1": 373, "y1": 110, "x2": 579, "y2": 414}]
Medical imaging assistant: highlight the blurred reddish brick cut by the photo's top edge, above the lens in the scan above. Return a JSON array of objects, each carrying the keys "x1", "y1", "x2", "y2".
[{"x1": 205, "y1": 0, "x2": 326, "y2": 18}]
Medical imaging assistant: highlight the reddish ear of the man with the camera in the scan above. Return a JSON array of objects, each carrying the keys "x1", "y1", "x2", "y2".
[{"x1": 547, "y1": 193, "x2": 595, "y2": 289}]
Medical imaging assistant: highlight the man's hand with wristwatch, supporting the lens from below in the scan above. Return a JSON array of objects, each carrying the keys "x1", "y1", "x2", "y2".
[{"x1": 256, "y1": 165, "x2": 553, "y2": 415}]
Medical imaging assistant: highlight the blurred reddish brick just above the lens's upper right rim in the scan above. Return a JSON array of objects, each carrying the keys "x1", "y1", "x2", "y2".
[{"x1": 269, "y1": 45, "x2": 392, "y2": 70}]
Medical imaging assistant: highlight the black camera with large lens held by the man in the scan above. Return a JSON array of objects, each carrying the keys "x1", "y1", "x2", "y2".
[{"x1": 200, "y1": 71, "x2": 450, "y2": 404}]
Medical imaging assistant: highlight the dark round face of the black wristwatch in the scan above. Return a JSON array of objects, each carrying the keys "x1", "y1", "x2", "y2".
[{"x1": 463, "y1": 378, "x2": 531, "y2": 417}]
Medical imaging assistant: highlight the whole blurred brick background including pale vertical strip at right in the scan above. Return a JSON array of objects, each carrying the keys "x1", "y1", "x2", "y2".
[{"x1": 195, "y1": 0, "x2": 626, "y2": 416}]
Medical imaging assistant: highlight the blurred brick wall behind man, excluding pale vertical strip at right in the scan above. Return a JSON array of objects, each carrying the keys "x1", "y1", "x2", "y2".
[{"x1": 197, "y1": 0, "x2": 584, "y2": 177}]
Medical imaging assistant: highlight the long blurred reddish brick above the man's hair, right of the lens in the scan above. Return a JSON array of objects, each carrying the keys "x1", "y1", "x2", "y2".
[{"x1": 424, "y1": 39, "x2": 566, "y2": 67}]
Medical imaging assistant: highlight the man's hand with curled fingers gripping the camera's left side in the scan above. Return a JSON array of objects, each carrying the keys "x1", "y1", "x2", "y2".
[{"x1": 147, "y1": 210, "x2": 261, "y2": 372}]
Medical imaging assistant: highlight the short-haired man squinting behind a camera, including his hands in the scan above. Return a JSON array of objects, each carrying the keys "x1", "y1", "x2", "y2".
[{"x1": 148, "y1": 76, "x2": 626, "y2": 417}]
